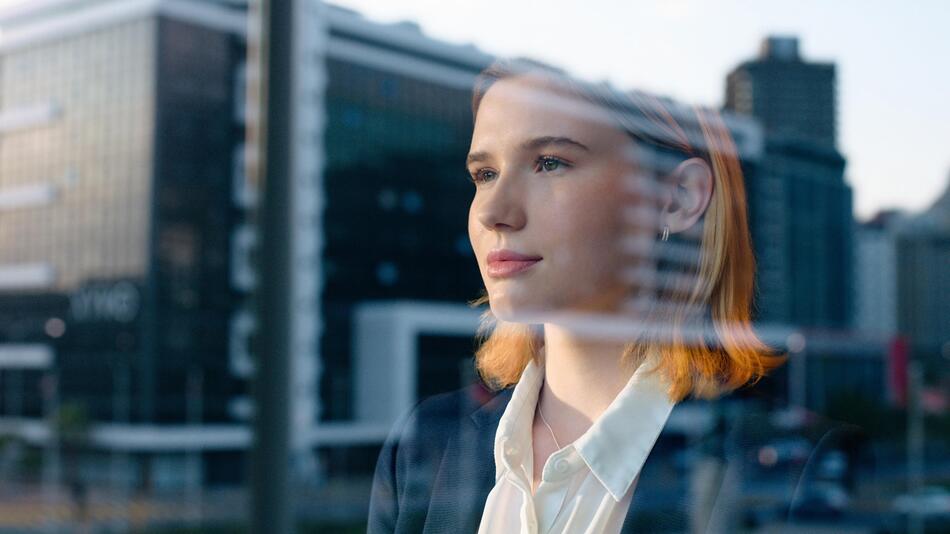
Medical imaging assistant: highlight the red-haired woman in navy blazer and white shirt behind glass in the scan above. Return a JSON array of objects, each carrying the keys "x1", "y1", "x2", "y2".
[{"x1": 369, "y1": 62, "x2": 840, "y2": 532}]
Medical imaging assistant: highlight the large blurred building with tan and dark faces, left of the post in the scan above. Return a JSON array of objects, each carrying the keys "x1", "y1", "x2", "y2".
[{"x1": 0, "y1": 1, "x2": 247, "y2": 490}]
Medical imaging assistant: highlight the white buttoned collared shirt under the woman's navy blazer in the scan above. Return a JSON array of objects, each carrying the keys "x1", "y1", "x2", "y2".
[{"x1": 478, "y1": 361, "x2": 673, "y2": 534}]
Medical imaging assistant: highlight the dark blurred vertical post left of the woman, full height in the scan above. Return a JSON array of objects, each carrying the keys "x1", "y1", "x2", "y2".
[{"x1": 251, "y1": 0, "x2": 294, "y2": 534}]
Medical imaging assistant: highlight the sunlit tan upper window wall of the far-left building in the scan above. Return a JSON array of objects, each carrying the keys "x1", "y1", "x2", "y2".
[{"x1": 0, "y1": 21, "x2": 154, "y2": 289}]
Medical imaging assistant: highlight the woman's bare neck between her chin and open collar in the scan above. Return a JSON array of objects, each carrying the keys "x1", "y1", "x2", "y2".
[{"x1": 538, "y1": 324, "x2": 635, "y2": 443}]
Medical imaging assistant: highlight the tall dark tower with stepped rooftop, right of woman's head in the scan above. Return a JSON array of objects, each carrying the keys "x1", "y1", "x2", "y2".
[{"x1": 725, "y1": 37, "x2": 852, "y2": 327}]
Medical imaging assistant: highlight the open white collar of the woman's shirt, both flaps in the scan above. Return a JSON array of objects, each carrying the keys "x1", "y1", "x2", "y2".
[{"x1": 495, "y1": 359, "x2": 673, "y2": 502}]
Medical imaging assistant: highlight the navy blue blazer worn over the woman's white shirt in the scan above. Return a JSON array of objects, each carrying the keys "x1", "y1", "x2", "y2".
[{"x1": 367, "y1": 384, "x2": 864, "y2": 534}]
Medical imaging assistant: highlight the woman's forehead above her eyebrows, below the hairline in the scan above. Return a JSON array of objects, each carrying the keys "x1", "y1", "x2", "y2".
[{"x1": 472, "y1": 75, "x2": 625, "y2": 145}]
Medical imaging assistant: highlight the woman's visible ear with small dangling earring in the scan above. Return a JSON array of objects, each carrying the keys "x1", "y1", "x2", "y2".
[{"x1": 660, "y1": 158, "x2": 713, "y2": 234}]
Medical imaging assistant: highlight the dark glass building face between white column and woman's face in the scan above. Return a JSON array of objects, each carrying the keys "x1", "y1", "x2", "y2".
[{"x1": 319, "y1": 9, "x2": 491, "y2": 426}]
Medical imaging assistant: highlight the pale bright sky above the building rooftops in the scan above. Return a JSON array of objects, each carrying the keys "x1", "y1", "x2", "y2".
[{"x1": 0, "y1": 0, "x2": 950, "y2": 219}]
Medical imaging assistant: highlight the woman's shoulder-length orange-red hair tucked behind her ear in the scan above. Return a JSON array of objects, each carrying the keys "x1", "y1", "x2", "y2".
[{"x1": 469, "y1": 60, "x2": 785, "y2": 402}]
